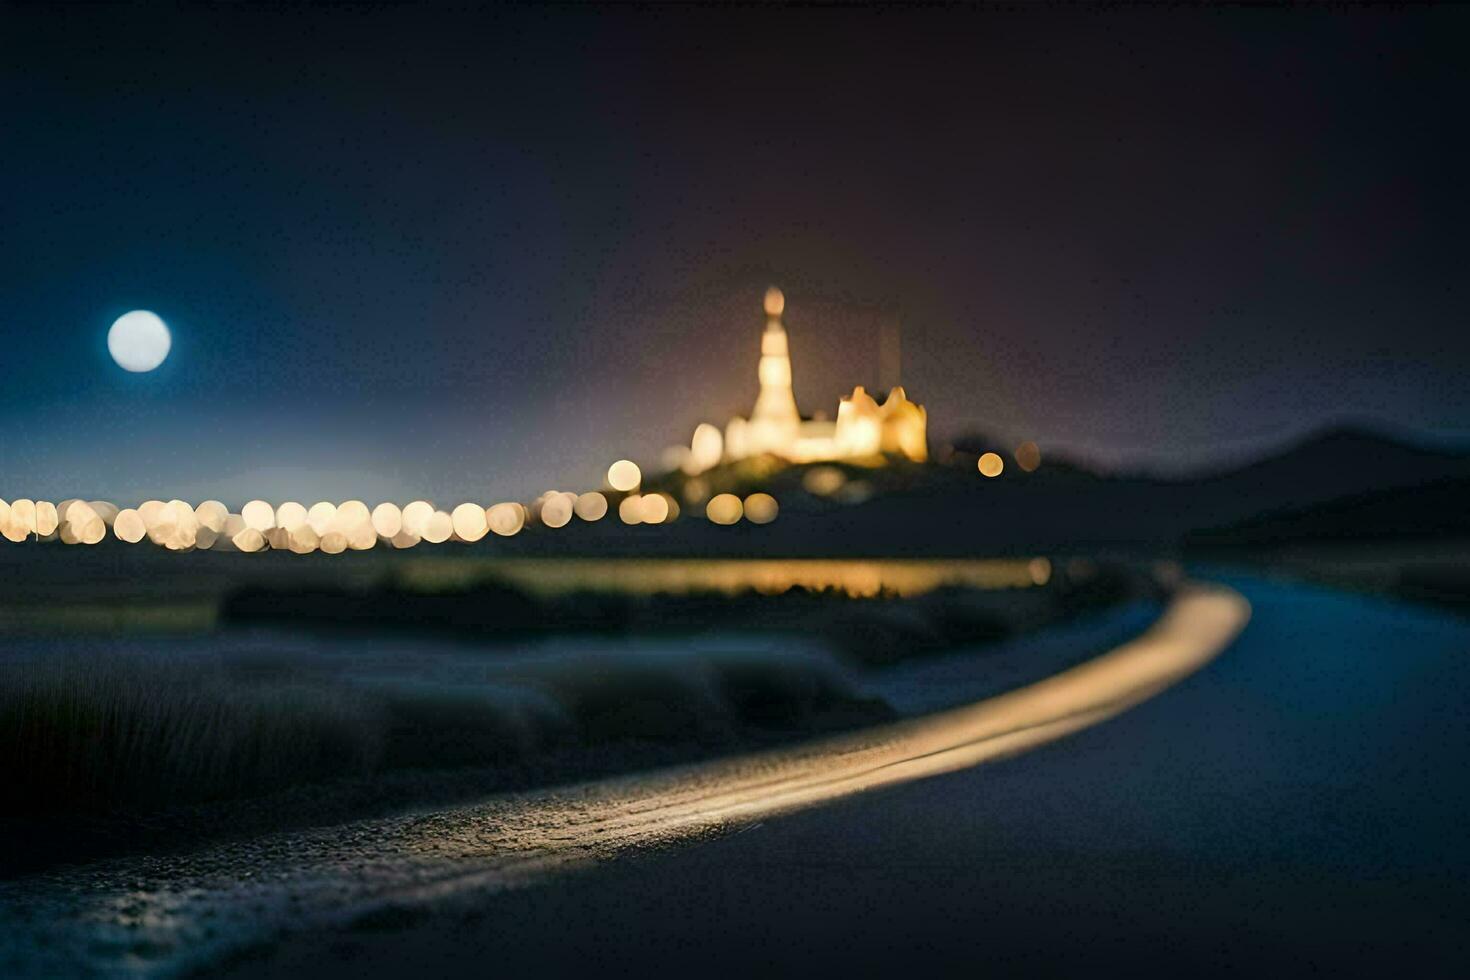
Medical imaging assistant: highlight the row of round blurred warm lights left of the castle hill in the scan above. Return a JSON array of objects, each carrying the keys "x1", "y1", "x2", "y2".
[{"x1": 0, "y1": 460, "x2": 779, "y2": 554}]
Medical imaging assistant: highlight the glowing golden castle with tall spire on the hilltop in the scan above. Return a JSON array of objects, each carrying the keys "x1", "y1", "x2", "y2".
[{"x1": 686, "y1": 287, "x2": 929, "y2": 472}]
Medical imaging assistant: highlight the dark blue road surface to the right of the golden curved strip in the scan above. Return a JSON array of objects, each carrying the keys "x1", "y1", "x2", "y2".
[{"x1": 210, "y1": 579, "x2": 1470, "y2": 977}]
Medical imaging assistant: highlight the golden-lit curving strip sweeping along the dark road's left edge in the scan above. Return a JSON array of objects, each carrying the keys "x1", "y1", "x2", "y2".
[{"x1": 3, "y1": 586, "x2": 1250, "y2": 974}]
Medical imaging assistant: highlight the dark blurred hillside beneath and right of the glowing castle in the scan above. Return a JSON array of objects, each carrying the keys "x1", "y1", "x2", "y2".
[{"x1": 476, "y1": 429, "x2": 1470, "y2": 557}]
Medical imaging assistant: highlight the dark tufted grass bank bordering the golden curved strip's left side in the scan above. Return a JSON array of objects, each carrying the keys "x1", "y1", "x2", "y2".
[{"x1": 0, "y1": 638, "x2": 882, "y2": 813}]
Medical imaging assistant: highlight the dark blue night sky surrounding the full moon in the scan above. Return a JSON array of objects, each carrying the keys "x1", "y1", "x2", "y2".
[{"x1": 0, "y1": 1, "x2": 1470, "y2": 504}]
